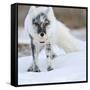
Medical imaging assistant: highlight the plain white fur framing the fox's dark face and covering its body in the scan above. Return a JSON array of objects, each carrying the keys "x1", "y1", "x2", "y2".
[{"x1": 24, "y1": 6, "x2": 79, "y2": 53}]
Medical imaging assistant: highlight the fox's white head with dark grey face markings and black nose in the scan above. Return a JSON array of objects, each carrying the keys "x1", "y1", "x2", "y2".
[{"x1": 24, "y1": 6, "x2": 55, "y2": 42}]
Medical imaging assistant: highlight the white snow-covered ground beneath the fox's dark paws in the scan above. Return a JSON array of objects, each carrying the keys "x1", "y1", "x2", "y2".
[{"x1": 18, "y1": 41, "x2": 86, "y2": 85}]
